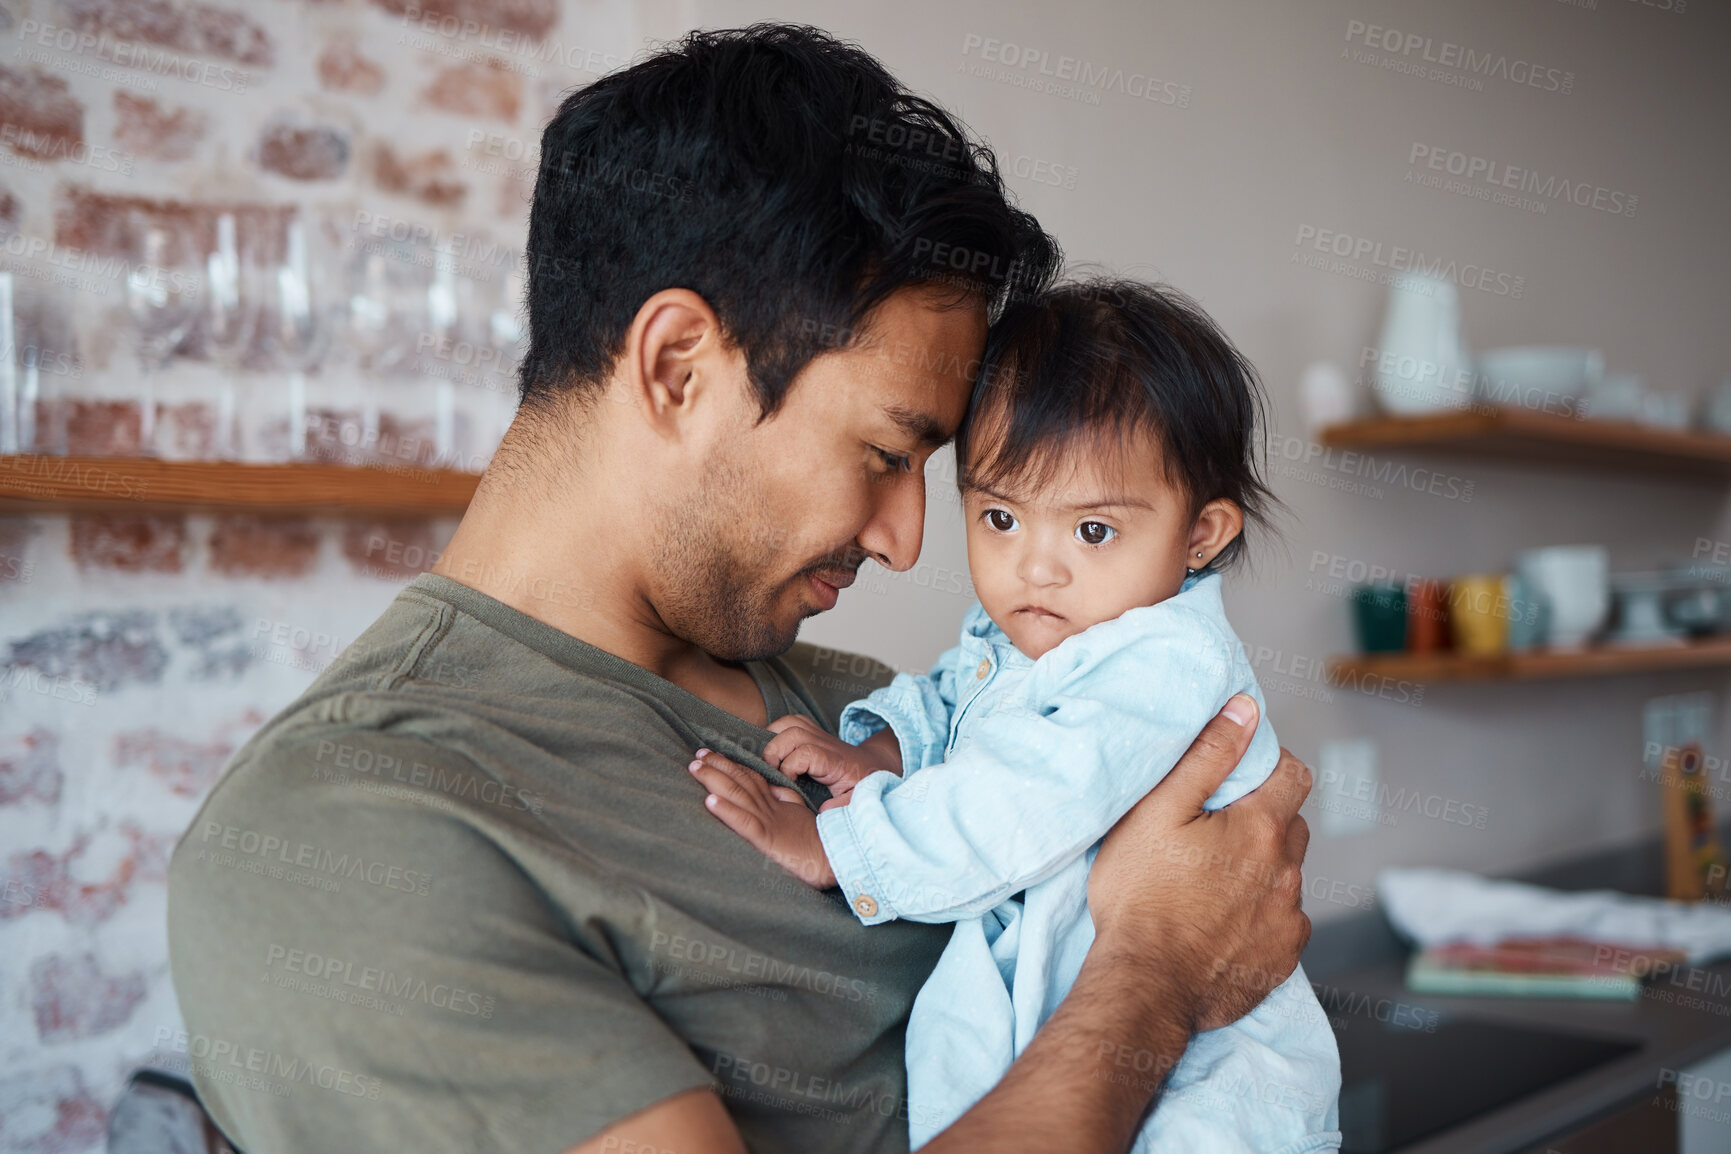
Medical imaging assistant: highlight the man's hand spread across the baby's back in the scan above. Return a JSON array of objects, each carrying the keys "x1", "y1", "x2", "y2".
[{"x1": 1089, "y1": 694, "x2": 1310, "y2": 1029}]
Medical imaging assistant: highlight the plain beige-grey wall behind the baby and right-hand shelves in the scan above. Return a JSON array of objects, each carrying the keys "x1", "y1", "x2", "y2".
[{"x1": 640, "y1": 0, "x2": 1731, "y2": 919}]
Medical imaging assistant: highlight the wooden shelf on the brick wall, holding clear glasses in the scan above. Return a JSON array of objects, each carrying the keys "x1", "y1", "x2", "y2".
[{"x1": 0, "y1": 455, "x2": 481, "y2": 517}]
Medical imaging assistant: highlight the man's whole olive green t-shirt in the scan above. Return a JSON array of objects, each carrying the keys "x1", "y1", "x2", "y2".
[{"x1": 168, "y1": 574, "x2": 950, "y2": 1154}]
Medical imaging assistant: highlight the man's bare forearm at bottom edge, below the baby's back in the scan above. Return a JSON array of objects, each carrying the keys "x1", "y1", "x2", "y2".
[{"x1": 923, "y1": 941, "x2": 1194, "y2": 1154}]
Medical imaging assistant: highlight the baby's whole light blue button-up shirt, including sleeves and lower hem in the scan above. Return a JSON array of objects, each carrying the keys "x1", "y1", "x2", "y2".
[{"x1": 817, "y1": 574, "x2": 1340, "y2": 1154}]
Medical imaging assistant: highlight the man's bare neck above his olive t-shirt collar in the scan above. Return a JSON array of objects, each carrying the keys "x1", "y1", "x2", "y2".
[{"x1": 433, "y1": 420, "x2": 769, "y2": 725}]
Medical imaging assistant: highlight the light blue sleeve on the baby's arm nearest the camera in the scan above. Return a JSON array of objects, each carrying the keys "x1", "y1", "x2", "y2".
[{"x1": 817, "y1": 606, "x2": 1279, "y2": 924}]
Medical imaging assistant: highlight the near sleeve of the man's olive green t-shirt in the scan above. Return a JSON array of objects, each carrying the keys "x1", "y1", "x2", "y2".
[{"x1": 164, "y1": 734, "x2": 715, "y2": 1154}]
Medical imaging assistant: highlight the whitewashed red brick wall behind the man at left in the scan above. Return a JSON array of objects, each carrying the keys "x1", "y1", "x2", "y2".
[{"x1": 0, "y1": 0, "x2": 635, "y2": 1154}]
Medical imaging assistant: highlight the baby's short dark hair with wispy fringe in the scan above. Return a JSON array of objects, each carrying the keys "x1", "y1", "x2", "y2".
[{"x1": 956, "y1": 277, "x2": 1277, "y2": 569}]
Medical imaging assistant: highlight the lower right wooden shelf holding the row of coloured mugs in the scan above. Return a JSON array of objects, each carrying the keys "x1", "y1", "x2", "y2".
[{"x1": 1328, "y1": 637, "x2": 1731, "y2": 685}]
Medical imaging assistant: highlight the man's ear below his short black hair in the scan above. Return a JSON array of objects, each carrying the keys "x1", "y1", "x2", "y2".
[{"x1": 609, "y1": 289, "x2": 739, "y2": 438}]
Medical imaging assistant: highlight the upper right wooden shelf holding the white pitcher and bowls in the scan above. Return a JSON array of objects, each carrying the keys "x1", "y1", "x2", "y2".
[{"x1": 1321, "y1": 408, "x2": 1731, "y2": 481}]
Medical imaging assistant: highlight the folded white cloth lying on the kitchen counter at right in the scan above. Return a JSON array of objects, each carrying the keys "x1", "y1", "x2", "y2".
[{"x1": 1376, "y1": 870, "x2": 1731, "y2": 962}]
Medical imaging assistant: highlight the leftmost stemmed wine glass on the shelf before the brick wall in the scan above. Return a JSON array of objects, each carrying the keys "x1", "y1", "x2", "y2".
[{"x1": 125, "y1": 209, "x2": 203, "y2": 455}]
